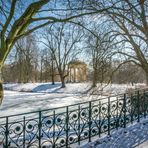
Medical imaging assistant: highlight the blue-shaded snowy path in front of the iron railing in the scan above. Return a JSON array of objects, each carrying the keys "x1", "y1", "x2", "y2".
[{"x1": 81, "y1": 119, "x2": 148, "y2": 148}]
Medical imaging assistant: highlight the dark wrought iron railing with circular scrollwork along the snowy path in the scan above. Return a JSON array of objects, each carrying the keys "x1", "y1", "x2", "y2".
[{"x1": 0, "y1": 91, "x2": 148, "y2": 148}]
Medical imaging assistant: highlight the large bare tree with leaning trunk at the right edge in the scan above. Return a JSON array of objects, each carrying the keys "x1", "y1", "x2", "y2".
[{"x1": 103, "y1": 0, "x2": 148, "y2": 84}]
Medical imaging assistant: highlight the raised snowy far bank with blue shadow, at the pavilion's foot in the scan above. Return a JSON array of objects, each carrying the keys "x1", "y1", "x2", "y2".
[{"x1": 4, "y1": 83, "x2": 145, "y2": 94}]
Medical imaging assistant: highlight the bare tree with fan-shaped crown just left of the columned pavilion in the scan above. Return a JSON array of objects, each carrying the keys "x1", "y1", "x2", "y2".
[{"x1": 42, "y1": 23, "x2": 83, "y2": 88}]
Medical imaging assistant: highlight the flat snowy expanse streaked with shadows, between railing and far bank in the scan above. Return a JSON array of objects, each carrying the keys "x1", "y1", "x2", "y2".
[{"x1": 0, "y1": 91, "x2": 80, "y2": 116}]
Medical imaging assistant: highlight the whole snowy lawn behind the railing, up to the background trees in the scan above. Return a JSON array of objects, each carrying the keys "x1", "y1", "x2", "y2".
[{"x1": 0, "y1": 83, "x2": 146, "y2": 117}]
